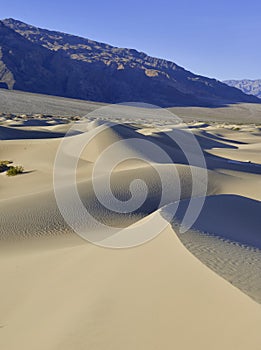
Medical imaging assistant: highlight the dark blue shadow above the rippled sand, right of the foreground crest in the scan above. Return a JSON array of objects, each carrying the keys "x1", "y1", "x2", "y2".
[{"x1": 165, "y1": 194, "x2": 261, "y2": 249}]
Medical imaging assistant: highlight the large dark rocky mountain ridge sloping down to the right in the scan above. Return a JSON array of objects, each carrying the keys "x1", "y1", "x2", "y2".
[{"x1": 0, "y1": 19, "x2": 260, "y2": 106}]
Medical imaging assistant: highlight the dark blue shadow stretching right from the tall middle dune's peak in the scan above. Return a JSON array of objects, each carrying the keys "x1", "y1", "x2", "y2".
[{"x1": 82, "y1": 124, "x2": 261, "y2": 178}]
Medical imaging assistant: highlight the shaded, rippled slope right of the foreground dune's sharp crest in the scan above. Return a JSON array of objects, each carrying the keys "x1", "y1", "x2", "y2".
[{"x1": 162, "y1": 195, "x2": 261, "y2": 304}]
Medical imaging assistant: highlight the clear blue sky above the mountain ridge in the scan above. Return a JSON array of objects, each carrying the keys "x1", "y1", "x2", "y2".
[{"x1": 1, "y1": 0, "x2": 261, "y2": 80}]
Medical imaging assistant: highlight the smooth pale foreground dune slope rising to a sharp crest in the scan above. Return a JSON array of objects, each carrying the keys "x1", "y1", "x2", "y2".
[{"x1": 0, "y1": 229, "x2": 261, "y2": 350}]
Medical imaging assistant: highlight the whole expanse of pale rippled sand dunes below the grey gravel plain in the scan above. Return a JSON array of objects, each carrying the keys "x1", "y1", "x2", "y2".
[{"x1": 0, "y1": 107, "x2": 261, "y2": 350}]
